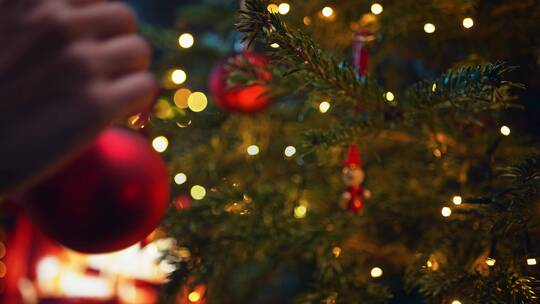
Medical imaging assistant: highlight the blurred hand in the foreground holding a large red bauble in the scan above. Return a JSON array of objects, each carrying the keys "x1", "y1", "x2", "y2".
[{"x1": 0, "y1": 0, "x2": 157, "y2": 193}]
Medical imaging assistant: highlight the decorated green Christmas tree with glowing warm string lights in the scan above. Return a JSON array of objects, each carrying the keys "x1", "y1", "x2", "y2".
[{"x1": 4, "y1": 0, "x2": 540, "y2": 304}]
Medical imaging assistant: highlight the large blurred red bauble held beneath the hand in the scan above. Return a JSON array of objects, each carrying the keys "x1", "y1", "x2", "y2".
[{"x1": 27, "y1": 128, "x2": 170, "y2": 253}]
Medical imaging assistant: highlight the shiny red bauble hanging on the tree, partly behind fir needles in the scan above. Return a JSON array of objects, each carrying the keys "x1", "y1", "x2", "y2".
[{"x1": 209, "y1": 52, "x2": 271, "y2": 113}]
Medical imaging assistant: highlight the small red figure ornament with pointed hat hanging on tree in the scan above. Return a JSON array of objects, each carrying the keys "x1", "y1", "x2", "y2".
[{"x1": 341, "y1": 144, "x2": 371, "y2": 214}]
